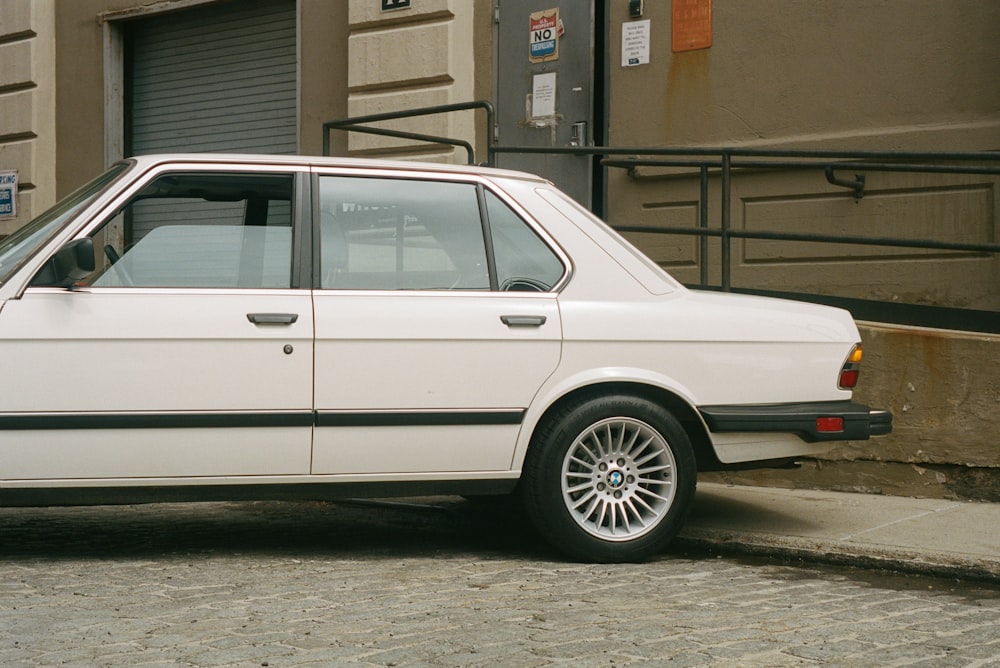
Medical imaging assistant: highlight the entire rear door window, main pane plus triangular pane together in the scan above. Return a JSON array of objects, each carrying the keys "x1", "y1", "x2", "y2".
[{"x1": 319, "y1": 176, "x2": 565, "y2": 292}]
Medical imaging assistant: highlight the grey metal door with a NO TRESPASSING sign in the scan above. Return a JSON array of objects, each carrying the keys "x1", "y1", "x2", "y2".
[{"x1": 493, "y1": 0, "x2": 595, "y2": 207}]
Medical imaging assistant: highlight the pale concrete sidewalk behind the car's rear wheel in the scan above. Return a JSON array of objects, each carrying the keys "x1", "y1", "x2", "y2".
[{"x1": 675, "y1": 483, "x2": 1000, "y2": 583}]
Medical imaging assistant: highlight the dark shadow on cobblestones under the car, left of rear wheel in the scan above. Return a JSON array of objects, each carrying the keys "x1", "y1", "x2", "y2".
[{"x1": 0, "y1": 497, "x2": 558, "y2": 560}]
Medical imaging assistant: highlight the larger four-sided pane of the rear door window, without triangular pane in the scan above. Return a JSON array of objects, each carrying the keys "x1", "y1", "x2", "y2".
[{"x1": 319, "y1": 176, "x2": 490, "y2": 290}]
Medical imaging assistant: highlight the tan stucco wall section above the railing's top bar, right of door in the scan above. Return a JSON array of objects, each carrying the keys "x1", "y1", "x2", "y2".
[{"x1": 610, "y1": 0, "x2": 1000, "y2": 151}]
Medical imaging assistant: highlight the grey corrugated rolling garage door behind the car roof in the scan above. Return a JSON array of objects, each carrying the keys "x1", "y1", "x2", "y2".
[{"x1": 126, "y1": 0, "x2": 298, "y2": 155}]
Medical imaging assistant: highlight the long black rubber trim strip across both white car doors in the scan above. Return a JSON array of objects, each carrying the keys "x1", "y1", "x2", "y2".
[{"x1": 0, "y1": 409, "x2": 524, "y2": 431}]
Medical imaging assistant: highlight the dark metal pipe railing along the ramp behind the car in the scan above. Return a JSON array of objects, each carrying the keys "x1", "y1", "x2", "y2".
[{"x1": 323, "y1": 100, "x2": 1000, "y2": 333}]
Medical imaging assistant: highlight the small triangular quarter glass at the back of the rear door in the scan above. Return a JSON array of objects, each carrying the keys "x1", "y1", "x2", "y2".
[{"x1": 486, "y1": 191, "x2": 565, "y2": 292}]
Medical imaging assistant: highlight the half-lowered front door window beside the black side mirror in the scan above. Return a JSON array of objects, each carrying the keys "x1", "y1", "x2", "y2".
[{"x1": 83, "y1": 173, "x2": 293, "y2": 288}]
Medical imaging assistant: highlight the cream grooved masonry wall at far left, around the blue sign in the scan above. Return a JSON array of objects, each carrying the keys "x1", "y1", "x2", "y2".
[{"x1": 0, "y1": 0, "x2": 56, "y2": 235}]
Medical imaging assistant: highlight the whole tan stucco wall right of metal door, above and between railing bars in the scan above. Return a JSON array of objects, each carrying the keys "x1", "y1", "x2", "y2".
[{"x1": 609, "y1": 0, "x2": 1000, "y2": 310}]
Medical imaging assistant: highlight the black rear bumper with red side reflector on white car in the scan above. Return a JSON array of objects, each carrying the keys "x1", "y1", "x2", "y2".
[{"x1": 698, "y1": 401, "x2": 892, "y2": 443}]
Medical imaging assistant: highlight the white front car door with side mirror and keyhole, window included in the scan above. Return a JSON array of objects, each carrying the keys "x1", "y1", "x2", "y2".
[{"x1": 0, "y1": 166, "x2": 313, "y2": 485}]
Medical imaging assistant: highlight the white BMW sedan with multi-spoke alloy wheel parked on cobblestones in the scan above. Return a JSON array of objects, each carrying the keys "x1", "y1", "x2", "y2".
[{"x1": 0, "y1": 154, "x2": 892, "y2": 561}]
